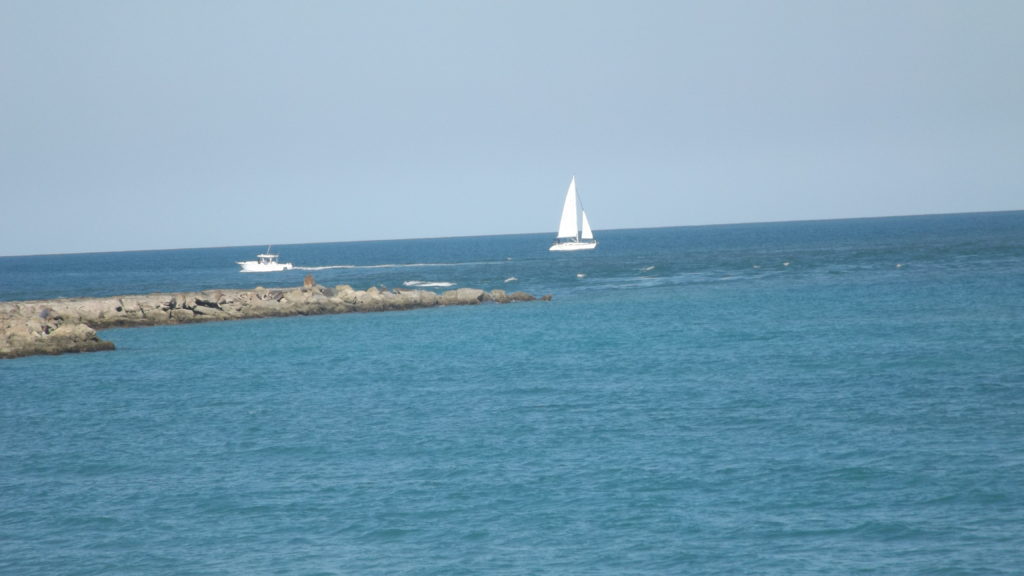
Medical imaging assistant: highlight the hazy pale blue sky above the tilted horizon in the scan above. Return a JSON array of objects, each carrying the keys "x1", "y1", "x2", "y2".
[{"x1": 0, "y1": 0, "x2": 1024, "y2": 255}]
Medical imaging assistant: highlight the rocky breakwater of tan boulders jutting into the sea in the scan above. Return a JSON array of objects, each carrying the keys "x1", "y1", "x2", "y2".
[{"x1": 0, "y1": 279, "x2": 550, "y2": 358}]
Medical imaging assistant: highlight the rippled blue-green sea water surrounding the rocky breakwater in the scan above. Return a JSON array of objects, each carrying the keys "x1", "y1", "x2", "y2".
[{"x1": 0, "y1": 212, "x2": 1024, "y2": 575}]
